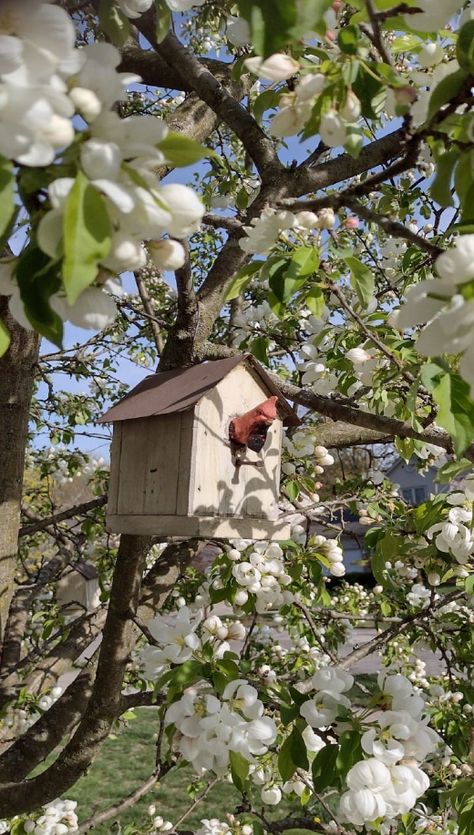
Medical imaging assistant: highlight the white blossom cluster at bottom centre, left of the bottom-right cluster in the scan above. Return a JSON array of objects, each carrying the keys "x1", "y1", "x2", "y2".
[{"x1": 165, "y1": 679, "x2": 276, "y2": 775}]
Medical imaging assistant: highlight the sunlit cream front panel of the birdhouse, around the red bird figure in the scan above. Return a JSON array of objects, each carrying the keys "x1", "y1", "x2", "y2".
[{"x1": 190, "y1": 366, "x2": 282, "y2": 519}]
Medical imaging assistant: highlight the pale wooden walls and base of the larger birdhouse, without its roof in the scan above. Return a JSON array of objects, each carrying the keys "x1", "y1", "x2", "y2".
[{"x1": 106, "y1": 354, "x2": 290, "y2": 539}]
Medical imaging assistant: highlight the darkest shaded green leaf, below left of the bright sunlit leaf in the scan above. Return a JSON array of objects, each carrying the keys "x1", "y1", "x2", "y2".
[{"x1": 15, "y1": 243, "x2": 63, "y2": 348}]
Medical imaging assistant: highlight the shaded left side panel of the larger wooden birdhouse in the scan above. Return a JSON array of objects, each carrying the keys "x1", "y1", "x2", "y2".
[{"x1": 114, "y1": 415, "x2": 180, "y2": 516}]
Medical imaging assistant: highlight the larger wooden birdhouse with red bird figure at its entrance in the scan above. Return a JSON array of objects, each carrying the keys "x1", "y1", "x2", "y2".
[{"x1": 100, "y1": 355, "x2": 299, "y2": 539}]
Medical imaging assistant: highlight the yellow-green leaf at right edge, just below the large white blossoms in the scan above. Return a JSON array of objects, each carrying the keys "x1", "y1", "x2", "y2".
[{"x1": 421, "y1": 363, "x2": 474, "y2": 455}]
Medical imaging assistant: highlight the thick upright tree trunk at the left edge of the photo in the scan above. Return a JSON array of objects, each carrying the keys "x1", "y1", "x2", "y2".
[{"x1": 0, "y1": 304, "x2": 39, "y2": 639}]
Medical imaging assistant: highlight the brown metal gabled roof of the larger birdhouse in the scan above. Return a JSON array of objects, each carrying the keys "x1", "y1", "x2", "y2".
[{"x1": 98, "y1": 354, "x2": 300, "y2": 425}]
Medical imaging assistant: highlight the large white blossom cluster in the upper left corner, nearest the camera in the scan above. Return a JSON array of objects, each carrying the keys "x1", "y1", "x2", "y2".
[{"x1": 0, "y1": 0, "x2": 204, "y2": 336}]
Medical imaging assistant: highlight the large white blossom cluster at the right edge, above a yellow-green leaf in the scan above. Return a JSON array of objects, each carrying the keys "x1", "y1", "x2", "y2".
[{"x1": 392, "y1": 234, "x2": 474, "y2": 392}]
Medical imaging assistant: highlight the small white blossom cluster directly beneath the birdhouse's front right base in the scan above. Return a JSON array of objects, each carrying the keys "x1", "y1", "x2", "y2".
[{"x1": 227, "y1": 542, "x2": 293, "y2": 614}]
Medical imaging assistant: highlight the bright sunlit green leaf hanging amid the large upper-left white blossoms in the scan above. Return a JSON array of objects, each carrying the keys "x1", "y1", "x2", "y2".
[{"x1": 63, "y1": 171, "x2": 112, "y2": 304}]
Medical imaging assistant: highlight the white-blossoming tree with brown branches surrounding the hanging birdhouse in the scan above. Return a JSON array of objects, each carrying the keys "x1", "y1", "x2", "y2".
[{"x1": 0, "y1": 0, "x2": 474, "y2": 835}]
